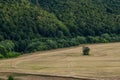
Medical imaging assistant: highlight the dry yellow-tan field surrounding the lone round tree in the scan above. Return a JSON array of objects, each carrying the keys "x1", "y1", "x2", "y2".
[{"x1": 0, "y1": 43, "x2": 120, "y2": 80}]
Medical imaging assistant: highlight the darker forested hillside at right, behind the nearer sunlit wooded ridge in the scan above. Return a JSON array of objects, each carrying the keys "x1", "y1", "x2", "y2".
[{"x1": 31, "y1": 0, "x2": 120, "y2": 36}]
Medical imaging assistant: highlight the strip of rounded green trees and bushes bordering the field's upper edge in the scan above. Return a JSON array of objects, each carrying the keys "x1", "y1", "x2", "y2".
[{"x1": 0, "y1": 34, "x2": 120, "y2": 58}]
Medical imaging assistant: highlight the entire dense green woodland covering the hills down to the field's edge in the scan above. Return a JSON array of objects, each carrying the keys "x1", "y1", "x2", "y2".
[{"x1": 0, "y1": 0, "x2": 120, "y2": 58}]
